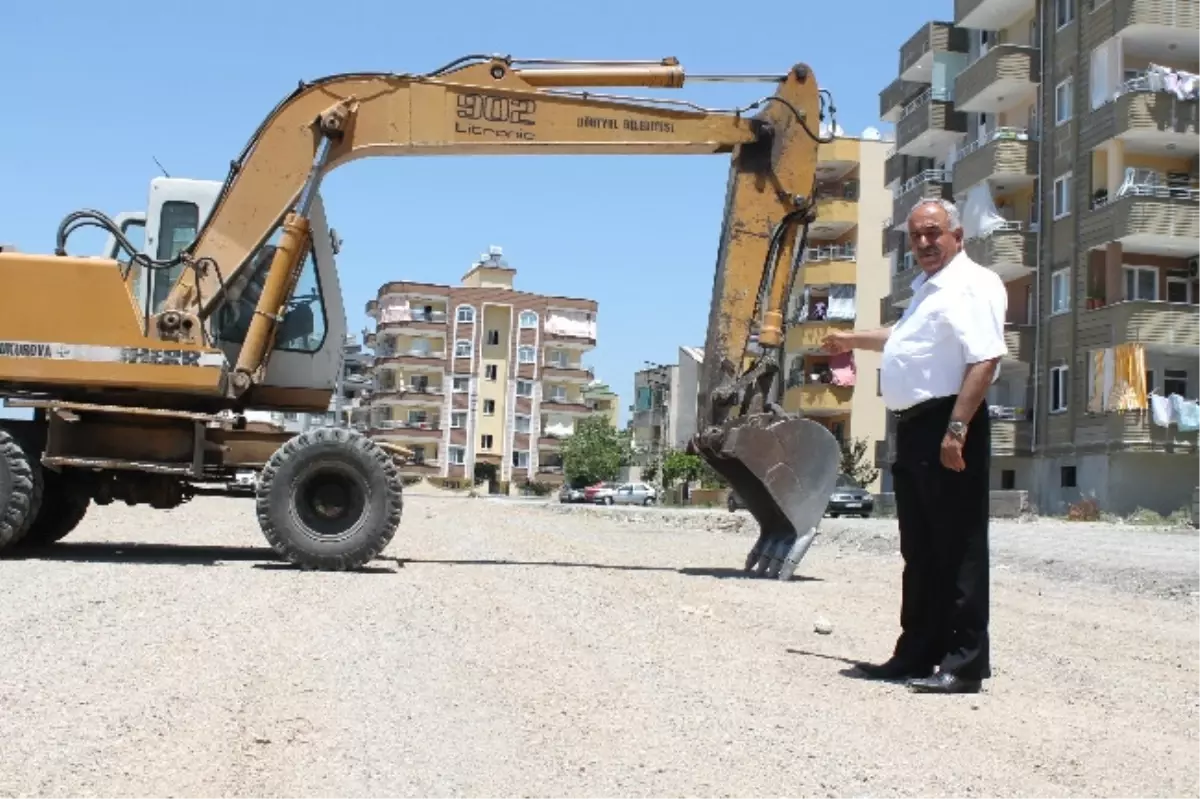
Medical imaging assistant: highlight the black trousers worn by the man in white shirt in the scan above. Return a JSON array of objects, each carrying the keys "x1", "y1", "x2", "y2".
[{"x1": 892, "y1": 397, "x2": 991, "y2": 679}]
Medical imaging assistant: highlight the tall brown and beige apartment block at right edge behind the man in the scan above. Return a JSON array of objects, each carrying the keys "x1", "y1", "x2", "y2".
[{"x1": 878, "y1": 0, "x2": 1200, "y2": 513}]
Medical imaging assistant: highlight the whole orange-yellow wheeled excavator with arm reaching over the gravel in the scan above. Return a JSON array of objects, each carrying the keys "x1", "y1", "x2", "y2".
[{"x1": 0, "y1": 55, "x2": 840, "y2": 581}]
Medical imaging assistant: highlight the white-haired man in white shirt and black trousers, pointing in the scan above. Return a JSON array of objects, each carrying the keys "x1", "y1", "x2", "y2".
[{"x1": 824, "y1": 199, "x2": 1008, "y2": 693}]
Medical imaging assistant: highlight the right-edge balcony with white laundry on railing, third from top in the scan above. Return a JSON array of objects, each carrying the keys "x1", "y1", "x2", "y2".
[{"x1": 1080, "y1": 169, "x2": 1200, "y2": 258}]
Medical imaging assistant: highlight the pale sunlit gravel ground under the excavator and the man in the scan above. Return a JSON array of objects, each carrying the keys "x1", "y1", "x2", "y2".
[{"x1": 0, "y1": 492, "x2": 1200, "y2": 799}]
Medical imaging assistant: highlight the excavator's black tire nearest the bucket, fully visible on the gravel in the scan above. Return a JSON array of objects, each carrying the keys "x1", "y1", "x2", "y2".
[{"x1": 256, "y1": 427, "x2": 404, "y2": 571}]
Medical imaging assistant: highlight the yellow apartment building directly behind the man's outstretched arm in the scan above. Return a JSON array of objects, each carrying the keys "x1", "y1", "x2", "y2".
[{"x1": 781, "y1": 130, "x2": 893, "y2": 491}]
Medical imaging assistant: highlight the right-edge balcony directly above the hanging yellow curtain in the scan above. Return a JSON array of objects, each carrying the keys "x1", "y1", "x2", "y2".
[{"x1": 1079, "y1": 300, "x2": 1200, "y2": 354}]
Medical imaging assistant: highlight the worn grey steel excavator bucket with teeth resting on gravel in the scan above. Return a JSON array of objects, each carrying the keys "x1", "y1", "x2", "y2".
[{"x1": 695, "y1": 413, "x2": 841, "y2": 581}]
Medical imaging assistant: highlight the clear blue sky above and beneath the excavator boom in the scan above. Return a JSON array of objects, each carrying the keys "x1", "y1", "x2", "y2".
[{"x1": 0, "y1": 0, "x2": 931, "y2": 421}]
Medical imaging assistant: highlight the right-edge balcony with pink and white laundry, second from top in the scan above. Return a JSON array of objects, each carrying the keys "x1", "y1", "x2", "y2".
[{"x1": 1080, "y1": 74, "x2": 1200, "y2": 155}]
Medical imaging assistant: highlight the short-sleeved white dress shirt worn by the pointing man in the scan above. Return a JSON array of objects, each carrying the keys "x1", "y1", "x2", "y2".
[{"x1": 880, "y1": 252, "x2": 1008, "y2": 410}]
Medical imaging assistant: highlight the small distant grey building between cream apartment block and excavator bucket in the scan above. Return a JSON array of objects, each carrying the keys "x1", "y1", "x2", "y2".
[{"x1": 629, "y1": 347, "x2": 704, "y2": 467}]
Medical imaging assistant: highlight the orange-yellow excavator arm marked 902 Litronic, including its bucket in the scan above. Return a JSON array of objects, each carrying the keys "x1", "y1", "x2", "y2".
[{"x1": 136, "y1": 56, "x2": 839, "y2": 578}]
